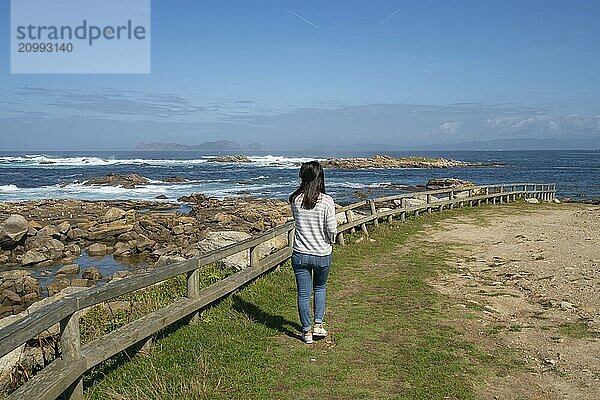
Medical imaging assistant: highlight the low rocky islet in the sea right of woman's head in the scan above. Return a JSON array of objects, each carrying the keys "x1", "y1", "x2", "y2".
[{"x1": 321, "y1": 155, "x2": 485, "y2": 170}]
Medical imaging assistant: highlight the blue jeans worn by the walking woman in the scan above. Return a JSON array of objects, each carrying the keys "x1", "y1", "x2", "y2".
[{"x1": 292, "y1": 252, "x2": 331, "y2": 332}]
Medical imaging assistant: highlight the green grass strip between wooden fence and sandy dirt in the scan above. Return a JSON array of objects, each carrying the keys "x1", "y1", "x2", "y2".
[{"x1": 86, "y1": 209, "x2": 516, "y2": 399}]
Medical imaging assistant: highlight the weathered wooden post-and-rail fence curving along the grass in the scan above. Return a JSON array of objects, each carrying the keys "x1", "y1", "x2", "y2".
[{"x1": 0, "y1": 183, "x2": 556, "y2": 400}]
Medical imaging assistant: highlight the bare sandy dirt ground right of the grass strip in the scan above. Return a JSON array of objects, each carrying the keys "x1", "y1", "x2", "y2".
[{"x1": 430, "y1": 205, "x2": 600, "y2": 399}]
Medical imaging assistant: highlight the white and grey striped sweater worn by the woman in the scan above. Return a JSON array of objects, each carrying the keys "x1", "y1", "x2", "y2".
[{"x1": 292, "y1": 194, "x2": 337, "y2": 256}]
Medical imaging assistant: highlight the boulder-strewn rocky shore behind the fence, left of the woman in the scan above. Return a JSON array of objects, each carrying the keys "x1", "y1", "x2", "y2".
[{"x1": 0, "y1": 194, "x2": 291, "y2": 318}]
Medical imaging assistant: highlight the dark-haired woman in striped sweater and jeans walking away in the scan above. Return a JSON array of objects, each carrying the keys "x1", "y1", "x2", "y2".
[{"x1": 290, "y1": 161, "x2": 337, "y2": 343}]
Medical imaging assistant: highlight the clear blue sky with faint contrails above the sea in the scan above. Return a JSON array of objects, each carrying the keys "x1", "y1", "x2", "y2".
[{"x1": 0, "y1": 0, "x2": 600, "y2": 150}]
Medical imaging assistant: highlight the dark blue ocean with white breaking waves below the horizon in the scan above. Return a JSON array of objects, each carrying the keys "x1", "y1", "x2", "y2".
[{"x1": 0, "y1": 150, "x2": 600, "y2": 203}]
